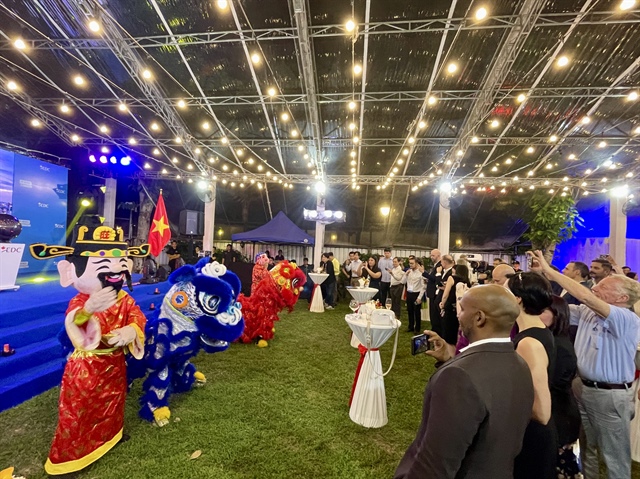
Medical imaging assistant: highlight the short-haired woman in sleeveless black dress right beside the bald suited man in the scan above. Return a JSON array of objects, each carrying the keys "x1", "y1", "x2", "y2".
[{"x1": 507, "y1": 272, "x2": 557, "y2": 479}]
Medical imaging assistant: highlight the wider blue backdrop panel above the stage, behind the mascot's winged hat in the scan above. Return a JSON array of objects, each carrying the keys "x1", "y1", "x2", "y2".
[{"x1": 13, "y1": 153, "x2": 68, "y2": 274}]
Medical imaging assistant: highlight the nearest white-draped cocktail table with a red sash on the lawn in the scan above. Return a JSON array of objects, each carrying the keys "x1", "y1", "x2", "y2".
[{"x1": 345, "y1": 314, "x2": 401, "y2": 428}]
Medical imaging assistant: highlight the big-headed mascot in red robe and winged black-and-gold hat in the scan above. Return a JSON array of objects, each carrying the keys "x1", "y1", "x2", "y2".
[{"x1": 29, "y1": 226, "x2": 149, "y2": 475}]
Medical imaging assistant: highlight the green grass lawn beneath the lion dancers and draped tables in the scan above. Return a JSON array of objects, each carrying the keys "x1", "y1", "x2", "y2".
[{"x1": 0, "y1": 301, "x2": 640, "y2": 479}]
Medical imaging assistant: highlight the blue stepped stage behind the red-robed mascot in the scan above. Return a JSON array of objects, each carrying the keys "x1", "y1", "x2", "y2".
[{"x1": 0, "y1": 274, "x2": 174, "y2": 412}]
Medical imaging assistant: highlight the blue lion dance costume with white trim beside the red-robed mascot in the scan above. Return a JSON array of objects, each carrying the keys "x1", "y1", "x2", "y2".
[{"x1": 129, "y1": 258, "x2": 244, "y2": 426}]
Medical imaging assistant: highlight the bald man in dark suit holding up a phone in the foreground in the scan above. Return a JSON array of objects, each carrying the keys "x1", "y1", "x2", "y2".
[{"x1": 394, "y1": 285, "x2": 533, "y2": 479}]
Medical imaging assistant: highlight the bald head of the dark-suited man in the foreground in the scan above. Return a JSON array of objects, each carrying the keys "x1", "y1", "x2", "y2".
[{"x1": 458, "y1": 284, "x2": 520, "y2": 342}]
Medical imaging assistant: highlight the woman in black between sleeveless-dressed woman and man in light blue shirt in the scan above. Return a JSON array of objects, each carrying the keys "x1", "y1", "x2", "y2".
[{"x1": 540, "y1": 296, "x2": 580, "y2": 479}]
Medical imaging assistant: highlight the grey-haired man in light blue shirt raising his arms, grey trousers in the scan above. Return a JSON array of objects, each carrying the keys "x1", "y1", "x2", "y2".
[{"x1": 535, "y1": 251, "x2": 640, "y2": 479}]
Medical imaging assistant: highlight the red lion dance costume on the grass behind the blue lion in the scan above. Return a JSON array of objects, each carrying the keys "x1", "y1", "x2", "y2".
[{"x1": 238, "y1": 261, "x2": 307, "y2": 348}]
